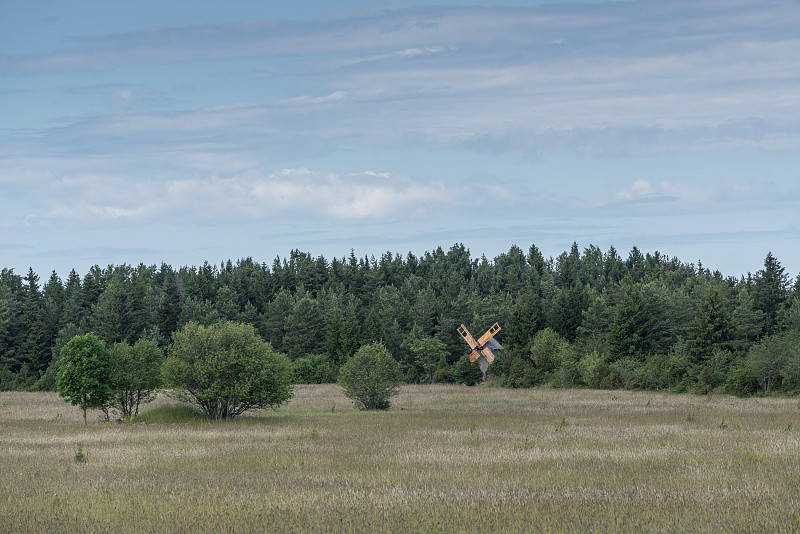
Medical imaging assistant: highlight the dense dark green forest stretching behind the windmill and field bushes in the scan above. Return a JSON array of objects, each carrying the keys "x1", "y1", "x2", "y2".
[{"x1": 0, "y1": 244, "x2": 800, "y2": 395}]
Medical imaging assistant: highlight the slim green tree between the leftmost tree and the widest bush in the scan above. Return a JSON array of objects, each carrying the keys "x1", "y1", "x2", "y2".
[{"x1": 109, "y1": 339, "x2": 164, "y2": 418}]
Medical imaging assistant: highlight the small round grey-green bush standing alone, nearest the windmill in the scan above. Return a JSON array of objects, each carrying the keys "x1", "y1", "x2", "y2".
[{"x1": 339, "y1": 342, "x2": 403, "y2": 410}]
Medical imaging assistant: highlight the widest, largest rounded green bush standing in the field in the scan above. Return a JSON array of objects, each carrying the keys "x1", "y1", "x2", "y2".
[{"x1": 163, "y1": 321, "x2": 292, "y2": 420}]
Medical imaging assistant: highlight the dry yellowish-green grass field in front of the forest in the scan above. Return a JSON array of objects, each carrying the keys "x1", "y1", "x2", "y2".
[{"x1": 0, "y1": 385, "x2": 800, "y2": 532}]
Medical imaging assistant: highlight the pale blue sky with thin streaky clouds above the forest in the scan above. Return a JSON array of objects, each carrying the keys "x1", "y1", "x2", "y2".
[{"x1": 0, "y1": 0, "x2": 800, "y2": 278}]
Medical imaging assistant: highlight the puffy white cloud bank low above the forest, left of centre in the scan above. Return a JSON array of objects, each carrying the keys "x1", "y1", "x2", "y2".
[{"x1": 28, "y1": 168, "x2": 452, "y2": 224}]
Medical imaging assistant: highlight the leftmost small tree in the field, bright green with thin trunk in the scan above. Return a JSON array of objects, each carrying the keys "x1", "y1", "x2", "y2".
[{"x1": 56, "y1": 334, "x2": 112, "y2": 424}]
